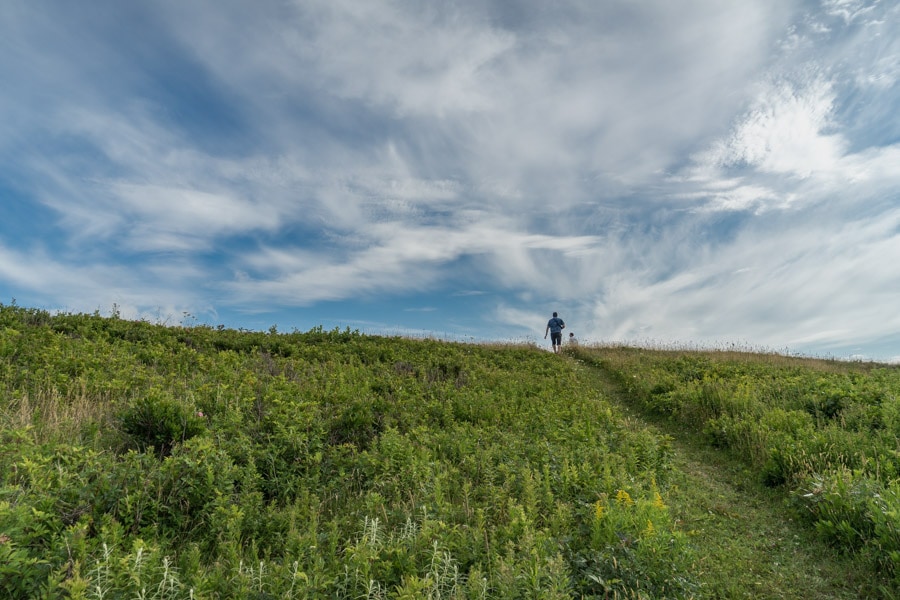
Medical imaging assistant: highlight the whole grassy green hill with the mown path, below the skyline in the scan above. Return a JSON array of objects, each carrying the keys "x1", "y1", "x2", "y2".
[{"x1": 0, "y1": 305, "x2": 900, "y2": 599}]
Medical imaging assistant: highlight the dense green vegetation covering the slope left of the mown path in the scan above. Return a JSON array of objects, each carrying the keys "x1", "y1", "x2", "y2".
[{"x1": 0, "y1": 306, "x2": 696, "y2": 598}]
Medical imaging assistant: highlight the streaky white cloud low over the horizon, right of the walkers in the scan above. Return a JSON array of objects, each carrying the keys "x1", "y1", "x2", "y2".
[{"x1": 580, "y1": 209, "x2": 900, "y2": 348}]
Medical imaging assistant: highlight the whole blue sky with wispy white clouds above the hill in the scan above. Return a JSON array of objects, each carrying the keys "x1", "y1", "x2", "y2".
[{"x1": 0, "y1": 0, "x2": 900, "y2": 361}]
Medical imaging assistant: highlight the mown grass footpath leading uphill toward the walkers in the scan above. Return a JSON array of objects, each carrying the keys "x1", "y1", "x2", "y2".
[{"x1": 568, "y1": 354, "x2": 883, "y2": 599}]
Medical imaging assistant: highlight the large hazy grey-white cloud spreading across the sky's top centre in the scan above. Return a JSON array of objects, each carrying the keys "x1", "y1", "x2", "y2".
[{"x1": 151, "y1": 2, "x2": 788, "y2": 210}]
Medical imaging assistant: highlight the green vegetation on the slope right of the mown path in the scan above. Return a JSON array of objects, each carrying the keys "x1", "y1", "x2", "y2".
[{"x1": 577, "y1": 348, "x2": 900, "y2": 597}]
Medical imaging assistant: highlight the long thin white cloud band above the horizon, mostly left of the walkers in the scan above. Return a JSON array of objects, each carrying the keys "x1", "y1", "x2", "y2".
[{"x1": 229, "y1": 215, "x2": 597, "y2": 305}]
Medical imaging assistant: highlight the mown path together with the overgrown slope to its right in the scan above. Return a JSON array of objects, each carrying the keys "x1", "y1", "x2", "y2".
[{"x1": 570, "y1": 348, "x2": 900, "y2": 598}]
